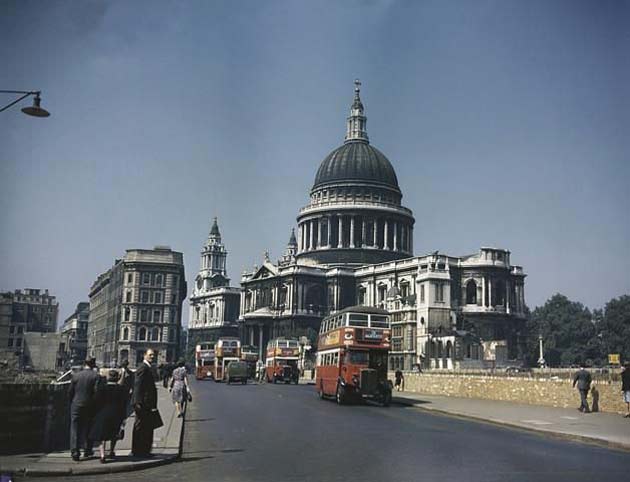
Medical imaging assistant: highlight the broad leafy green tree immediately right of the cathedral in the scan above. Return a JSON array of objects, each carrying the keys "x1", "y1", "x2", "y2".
[{"x1": 526, "y1": 293, "x2": 602, "y2": 366}]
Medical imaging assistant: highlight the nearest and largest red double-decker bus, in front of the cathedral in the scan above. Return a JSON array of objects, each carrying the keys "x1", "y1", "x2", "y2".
[{"x1": 315, "y1": 306, "x2": 392, "y2": 406}]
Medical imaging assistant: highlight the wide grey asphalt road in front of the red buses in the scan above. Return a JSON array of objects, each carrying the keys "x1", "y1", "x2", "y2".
[{"x1": 25, "y1": 382, "x2": 630, "y2": 482}]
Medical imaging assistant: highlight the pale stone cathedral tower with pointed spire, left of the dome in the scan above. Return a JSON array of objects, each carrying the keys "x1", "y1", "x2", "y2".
[{"x1": 188, "y1": 218, "x2": 241, "y2": 346}]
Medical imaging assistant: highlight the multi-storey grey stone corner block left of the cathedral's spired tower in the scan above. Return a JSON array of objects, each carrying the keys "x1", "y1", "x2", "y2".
[{"x1": 88, "y1": 246, "x2": 186, "y2": 367}]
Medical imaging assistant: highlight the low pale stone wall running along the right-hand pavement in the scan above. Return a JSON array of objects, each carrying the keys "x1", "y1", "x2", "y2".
[{"x1": 389, "y1": 372, "x2": 626, "y2": 413}]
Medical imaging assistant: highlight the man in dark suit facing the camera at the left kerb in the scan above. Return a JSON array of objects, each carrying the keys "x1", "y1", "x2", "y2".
[{"x1": 131, "y1": 348, "x2": 157, "y2": 457}]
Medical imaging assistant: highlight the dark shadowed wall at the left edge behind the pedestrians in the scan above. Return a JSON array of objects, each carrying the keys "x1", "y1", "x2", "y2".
[{"x1": 0, "y1": 383, "x2": 70, "y2": 455}]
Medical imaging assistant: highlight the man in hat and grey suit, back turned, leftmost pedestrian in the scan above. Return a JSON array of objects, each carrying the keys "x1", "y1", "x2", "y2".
[{"x1": 69, "y1": 358, "x2": 100, "y2": 462}]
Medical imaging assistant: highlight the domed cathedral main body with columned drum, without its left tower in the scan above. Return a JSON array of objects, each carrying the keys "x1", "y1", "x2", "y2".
[{"x1": 241, "y1": 82, "x2": 525, "y2": 369}]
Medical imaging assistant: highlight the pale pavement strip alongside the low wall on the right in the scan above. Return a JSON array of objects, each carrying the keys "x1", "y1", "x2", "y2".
[{"x1": 393, "y1": 392, "x2": 630, "y2": 450}]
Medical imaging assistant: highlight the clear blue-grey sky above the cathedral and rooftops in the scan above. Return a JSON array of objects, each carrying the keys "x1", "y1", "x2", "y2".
[{"x1": 0, "y1": 0, "x2": 630, "y2": 323}]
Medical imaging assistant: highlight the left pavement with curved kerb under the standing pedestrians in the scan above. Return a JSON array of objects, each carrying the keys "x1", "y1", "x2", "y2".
[{"x1": 0, "y1": 383, "x2": 184, "y2": 477}]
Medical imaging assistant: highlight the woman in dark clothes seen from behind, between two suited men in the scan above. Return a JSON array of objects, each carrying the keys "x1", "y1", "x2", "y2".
[{"x1": 90, "y1": 370, "x2": 127, "y2": 464}]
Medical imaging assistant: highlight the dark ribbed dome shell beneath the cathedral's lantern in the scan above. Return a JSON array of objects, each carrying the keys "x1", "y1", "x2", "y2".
[{"x1": 313, "y1": 140, "x2": 400, "y2": 191}]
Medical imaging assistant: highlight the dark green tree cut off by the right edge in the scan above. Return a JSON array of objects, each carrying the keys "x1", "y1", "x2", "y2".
[{"x1": 597, "y1": 295, "x2": 630, "y2": 363}]
